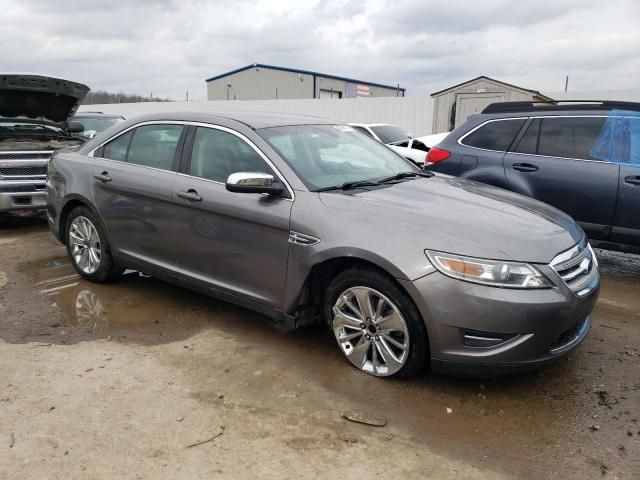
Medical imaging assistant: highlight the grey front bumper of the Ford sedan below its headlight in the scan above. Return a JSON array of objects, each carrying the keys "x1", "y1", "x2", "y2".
[{"x1": 401, "y1": 272, "x2": 599, "y2": 376}]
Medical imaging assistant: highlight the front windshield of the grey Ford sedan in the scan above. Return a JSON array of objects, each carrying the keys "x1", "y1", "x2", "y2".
[{"x1": 258, "y1": 125, "x2": 420, "y2": 190}]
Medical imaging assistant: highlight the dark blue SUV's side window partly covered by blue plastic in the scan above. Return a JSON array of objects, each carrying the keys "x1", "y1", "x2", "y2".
[{"x1": 538, "y1": 117, "x2": 606, "y2": 160}]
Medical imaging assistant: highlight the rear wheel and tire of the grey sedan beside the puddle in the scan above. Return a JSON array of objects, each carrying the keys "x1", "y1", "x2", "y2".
[{"x1": 64, "y1": 207, "x2": 124, "y2": 283}]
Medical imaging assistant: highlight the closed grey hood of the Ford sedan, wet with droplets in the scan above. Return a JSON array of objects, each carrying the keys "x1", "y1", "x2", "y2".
[{"x1": 320, "y1": 175, "x2": 584, "y2": 264}]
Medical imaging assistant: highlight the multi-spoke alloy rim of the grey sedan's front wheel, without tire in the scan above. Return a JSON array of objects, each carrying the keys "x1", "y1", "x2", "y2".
[{"x1": 332, "y1": 287, "x2": 409, "y2": 377}]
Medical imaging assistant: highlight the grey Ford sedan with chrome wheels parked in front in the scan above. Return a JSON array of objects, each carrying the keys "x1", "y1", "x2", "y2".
[{"x1": 47, "y1": 112, "x2": 599, "y2": 377}]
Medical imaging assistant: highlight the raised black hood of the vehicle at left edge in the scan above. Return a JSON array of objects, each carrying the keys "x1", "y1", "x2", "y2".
[{"x1": 0, "y1": 73, "x2": 89, "y2": 124}]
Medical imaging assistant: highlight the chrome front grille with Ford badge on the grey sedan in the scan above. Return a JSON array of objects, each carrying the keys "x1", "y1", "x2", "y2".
[{"x1": 551, "y1": 239, "x2": 598, "y2": 297}]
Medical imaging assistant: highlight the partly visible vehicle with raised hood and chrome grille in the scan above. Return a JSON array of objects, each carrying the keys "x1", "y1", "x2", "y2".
[{"x1": 0, "y1": 74, "x2": 89, "y2": 214}]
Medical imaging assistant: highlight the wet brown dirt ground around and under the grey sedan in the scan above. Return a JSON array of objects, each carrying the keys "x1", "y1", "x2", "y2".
[{"x1": 0, "y1": 219, "x2": 640, "y2": 479}]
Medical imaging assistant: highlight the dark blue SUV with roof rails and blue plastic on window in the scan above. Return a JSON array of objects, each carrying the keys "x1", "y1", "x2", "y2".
[{"x1": 427, "y1": 102, "x2": 640, "y2": 252}]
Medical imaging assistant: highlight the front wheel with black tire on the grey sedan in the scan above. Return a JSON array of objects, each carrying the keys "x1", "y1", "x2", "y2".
[{"x1": 324, "y1": 267, "x2": 429, "y2": 378}]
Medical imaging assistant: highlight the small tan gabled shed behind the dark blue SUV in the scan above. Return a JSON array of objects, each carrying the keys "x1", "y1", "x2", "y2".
[{"x1": 431, "y1": 76, "x2": 552, "y2": 132}]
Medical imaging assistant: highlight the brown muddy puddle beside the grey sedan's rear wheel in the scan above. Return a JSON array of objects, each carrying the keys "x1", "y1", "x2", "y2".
[{"x1": 8, "y1": 255, "x2": 288, "y2": 344}]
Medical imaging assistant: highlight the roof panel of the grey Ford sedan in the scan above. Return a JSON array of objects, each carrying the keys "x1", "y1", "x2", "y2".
[{"x1": 122, "y1": 110, "x2": 342, "y2": 130}]
